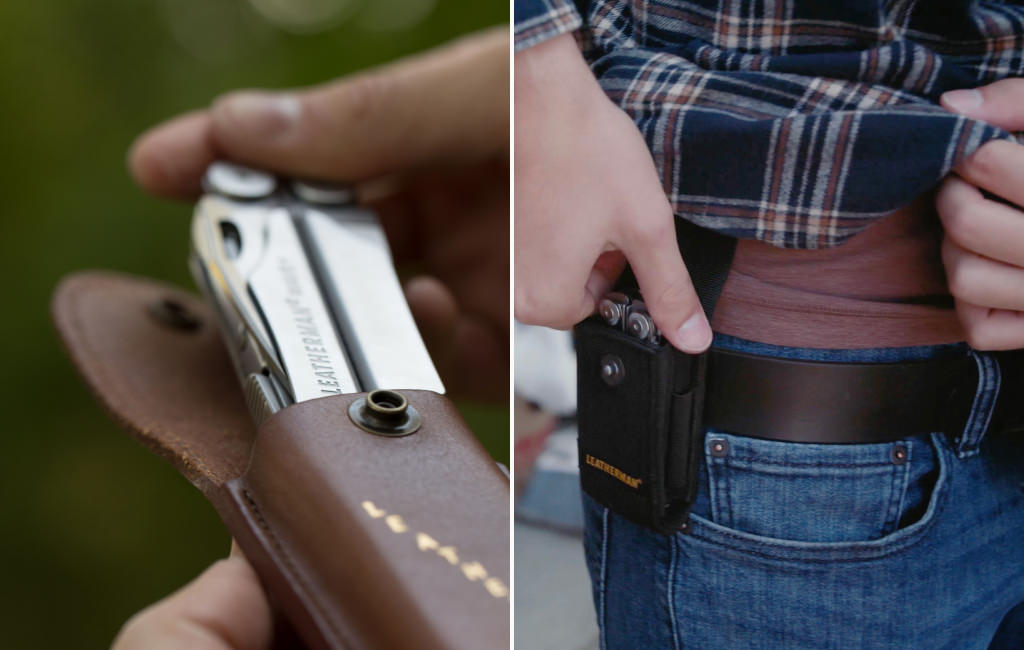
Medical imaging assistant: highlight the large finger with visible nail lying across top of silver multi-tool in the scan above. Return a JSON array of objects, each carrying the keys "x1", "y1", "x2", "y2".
[{"x1": 211, "y1": 30, "x2": 509, "y2": 181}]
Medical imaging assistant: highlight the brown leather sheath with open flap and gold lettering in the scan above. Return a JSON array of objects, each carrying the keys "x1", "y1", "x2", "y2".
[{"x1": 53, "y1": 272, "x2": 510, "y2": 649}]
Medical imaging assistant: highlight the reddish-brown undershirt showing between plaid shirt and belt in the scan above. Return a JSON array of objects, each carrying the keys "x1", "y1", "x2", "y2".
[{"x1": 712, "y1": 194, "x2": 965, "y2": 349}]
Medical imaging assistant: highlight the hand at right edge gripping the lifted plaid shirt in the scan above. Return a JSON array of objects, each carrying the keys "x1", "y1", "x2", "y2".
[{"x1": 936, "y1": 79, "x2": 1024, "y2": 350}]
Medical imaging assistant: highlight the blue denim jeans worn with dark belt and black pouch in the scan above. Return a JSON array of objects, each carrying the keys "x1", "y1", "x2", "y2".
[{"x1": 584, "y1": 337, "x2": 1024, "y2": 650}]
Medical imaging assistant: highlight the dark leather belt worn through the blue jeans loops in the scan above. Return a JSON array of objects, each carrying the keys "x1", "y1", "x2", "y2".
[{"x1": 703, "y1": 349, "x2": 1024, "y2": 443}]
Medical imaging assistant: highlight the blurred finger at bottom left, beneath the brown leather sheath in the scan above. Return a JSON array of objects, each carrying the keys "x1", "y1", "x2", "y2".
[{"x1": 114, "y1": 558, "x2": 271, "y2": 650}]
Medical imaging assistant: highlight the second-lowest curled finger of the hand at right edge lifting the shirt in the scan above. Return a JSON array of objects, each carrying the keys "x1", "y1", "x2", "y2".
[{"x1": 942, "y1": 237, "x2": 1024, "y2": 309}]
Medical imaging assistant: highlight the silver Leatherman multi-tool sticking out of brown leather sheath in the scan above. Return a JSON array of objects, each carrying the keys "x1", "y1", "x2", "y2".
[{"x1": 191, "y1": 162, "x2": 444, "y2": 422}]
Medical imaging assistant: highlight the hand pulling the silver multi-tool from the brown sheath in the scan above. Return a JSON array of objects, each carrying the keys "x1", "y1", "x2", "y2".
[{"x1": 129, "y1": 29, "x2": 509, "y2": 403}]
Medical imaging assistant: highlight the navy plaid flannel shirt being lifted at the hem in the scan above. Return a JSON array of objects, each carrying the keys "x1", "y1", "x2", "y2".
[{"x1": 515, "y1": 0, "x2": 1024, "y2": 249}]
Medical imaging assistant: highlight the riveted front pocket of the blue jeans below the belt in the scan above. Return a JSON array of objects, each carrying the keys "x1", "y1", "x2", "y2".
[{"x1": 694, "y1": 431, "x2": 941, "y2": 545}]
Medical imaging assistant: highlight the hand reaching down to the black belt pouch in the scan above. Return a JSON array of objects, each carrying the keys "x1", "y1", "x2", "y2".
[{"x1": 515, "y1": 34, "x2": 712, "y2": 352}]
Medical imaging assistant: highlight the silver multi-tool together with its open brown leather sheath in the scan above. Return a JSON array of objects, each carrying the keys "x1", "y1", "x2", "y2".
[{"x1": 54, "y1": 163, "x2": 510, "y2": 650}]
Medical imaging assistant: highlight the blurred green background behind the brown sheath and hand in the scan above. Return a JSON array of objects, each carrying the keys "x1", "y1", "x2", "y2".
[{"x1": 0, "y1": 0, "x2": 509, "y2": 648}]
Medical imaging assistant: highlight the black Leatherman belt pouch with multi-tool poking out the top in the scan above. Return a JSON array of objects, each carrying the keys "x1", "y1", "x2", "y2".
[{"x1": 575, "y1": 290, "x2": 707, "y2": 534}]
